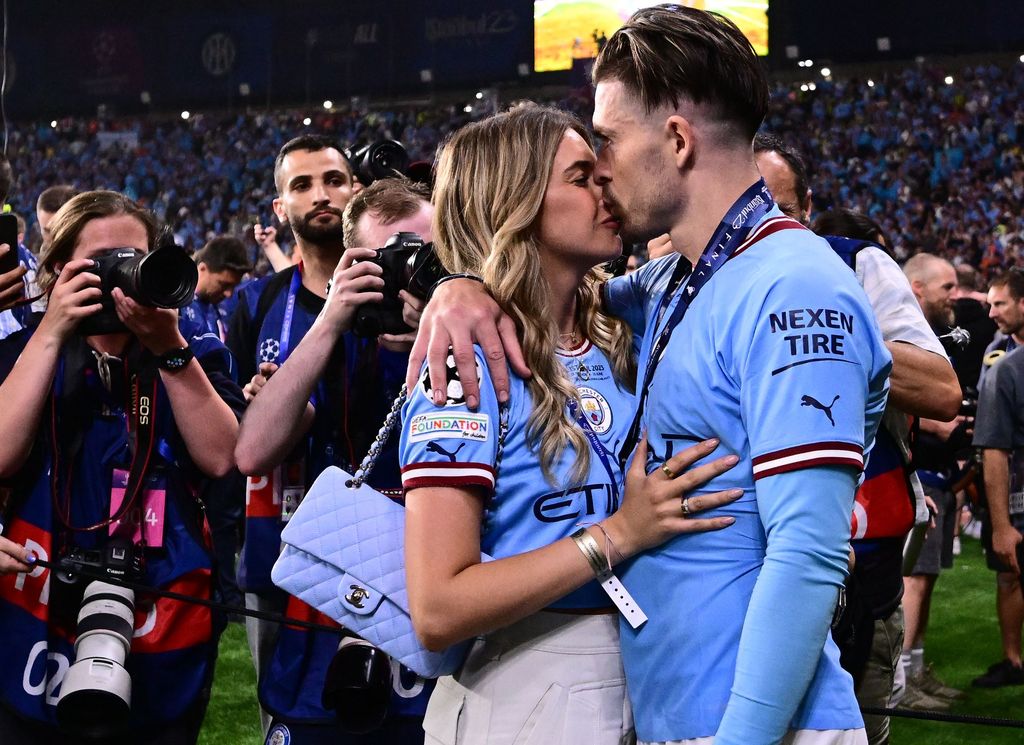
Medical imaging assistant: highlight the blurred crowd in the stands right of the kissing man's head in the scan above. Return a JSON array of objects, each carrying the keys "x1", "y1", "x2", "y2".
[{"x1": 766, "y1": 58, "x2": 1024, "y2": 276}]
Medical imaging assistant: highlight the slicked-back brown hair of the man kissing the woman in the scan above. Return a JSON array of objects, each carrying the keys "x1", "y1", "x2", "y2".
[{"x1": 593, "y1": 4, "x2": 769, "y2": 139}]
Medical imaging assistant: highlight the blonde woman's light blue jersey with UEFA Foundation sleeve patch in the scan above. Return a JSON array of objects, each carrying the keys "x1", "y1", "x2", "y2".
[{"x1": 399, "y1": 342, "x2": 636, "y2": 608}]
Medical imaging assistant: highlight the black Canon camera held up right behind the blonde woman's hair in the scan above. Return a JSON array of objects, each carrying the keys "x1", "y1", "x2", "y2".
[{"x1": 353, "y1": 232, "x2": 447, "y2": 337}]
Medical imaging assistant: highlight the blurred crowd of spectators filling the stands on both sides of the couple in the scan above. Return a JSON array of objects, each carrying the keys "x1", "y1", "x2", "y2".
[{"x1": 10, "y1": 59, "x2": 1024, "y2": 276}]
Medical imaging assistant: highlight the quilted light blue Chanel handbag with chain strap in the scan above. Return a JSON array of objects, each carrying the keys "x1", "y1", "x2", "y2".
[{"x1": 270, "y1": 389, "x2": 507, "y2": 677}]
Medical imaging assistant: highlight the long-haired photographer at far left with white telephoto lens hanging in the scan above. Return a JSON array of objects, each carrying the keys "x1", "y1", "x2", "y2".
[{"x1": 0, "y1": 191, "x2": 242, "y2": 745}]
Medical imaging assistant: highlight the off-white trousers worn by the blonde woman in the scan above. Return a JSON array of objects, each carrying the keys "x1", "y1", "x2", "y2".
[{"x1": 423, "y1": 612, "x2": 635, "y2": 745}]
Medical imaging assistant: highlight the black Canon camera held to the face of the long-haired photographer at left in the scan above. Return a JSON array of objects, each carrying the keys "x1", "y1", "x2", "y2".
[{"x1": 78, "y1": 236, "x2": 199, "y2": 336}]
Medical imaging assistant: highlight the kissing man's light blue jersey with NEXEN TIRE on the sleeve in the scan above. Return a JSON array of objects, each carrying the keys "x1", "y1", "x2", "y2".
[{"x1": 605, "y1": 208, "x2": 891, "y2": 742}]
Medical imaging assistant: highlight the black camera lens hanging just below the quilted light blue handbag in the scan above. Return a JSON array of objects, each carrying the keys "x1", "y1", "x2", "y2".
[{"x1": 321, "y1": 637, "x2": 391, "y2": 735}]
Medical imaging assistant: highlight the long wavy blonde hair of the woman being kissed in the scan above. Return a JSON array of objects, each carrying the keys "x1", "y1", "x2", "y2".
[{"x1": 433, "y1": 104, "x2": 636, "y2": 482}]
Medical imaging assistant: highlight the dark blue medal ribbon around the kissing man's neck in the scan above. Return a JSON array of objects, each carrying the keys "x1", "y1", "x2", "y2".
[{"x1": 618, "y1": 178, "x2": 775, "y2": 468}]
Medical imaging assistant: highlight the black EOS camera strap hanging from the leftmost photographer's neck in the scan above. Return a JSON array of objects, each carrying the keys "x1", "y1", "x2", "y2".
[{"x1": 49, "y1": 340, "x2": 160, "y2": 532}]
